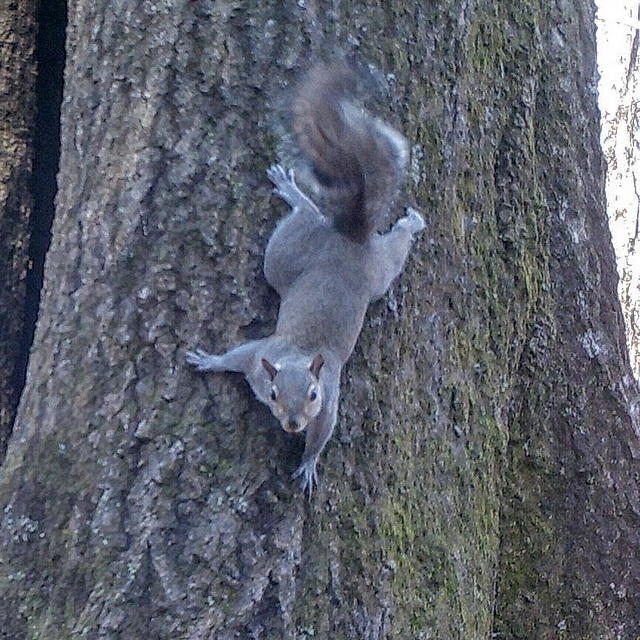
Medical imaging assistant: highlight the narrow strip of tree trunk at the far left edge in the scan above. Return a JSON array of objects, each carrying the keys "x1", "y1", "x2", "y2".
[{"x1": 0, "y1": 0, "x2": 36, "y2": 461}]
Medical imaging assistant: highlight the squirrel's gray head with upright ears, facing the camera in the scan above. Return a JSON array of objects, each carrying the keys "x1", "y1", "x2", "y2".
[{"x1": 262, "y1": 354, "x2": 324, "y2": 433}]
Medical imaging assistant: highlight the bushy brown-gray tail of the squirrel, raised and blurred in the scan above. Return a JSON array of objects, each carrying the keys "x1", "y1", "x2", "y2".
[{"x1": 292, "y1": 61, "x2": 408, "y2": 242}]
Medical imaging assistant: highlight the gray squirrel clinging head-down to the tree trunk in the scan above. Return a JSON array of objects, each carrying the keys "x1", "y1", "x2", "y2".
[{"x1": 186, "y1": 62, "x2": 424, "y2": 497}]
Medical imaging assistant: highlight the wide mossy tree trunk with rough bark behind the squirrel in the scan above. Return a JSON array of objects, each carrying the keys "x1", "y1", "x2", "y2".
[{"x1": 0, "y1": 0, "x2": 640, "y2": 640}]
